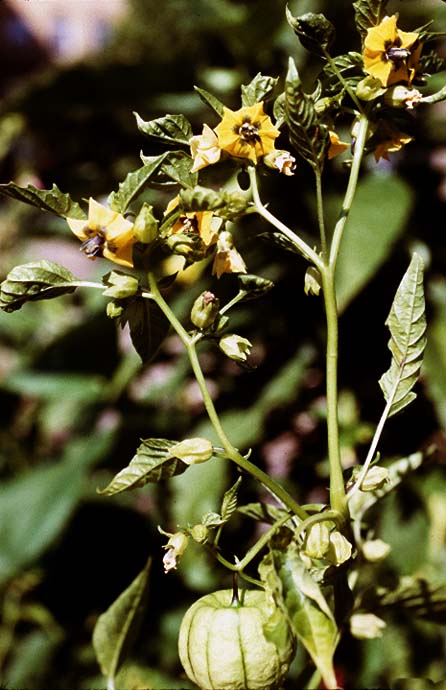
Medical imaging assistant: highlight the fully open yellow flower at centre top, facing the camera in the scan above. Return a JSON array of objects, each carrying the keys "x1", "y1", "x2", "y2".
[{"x1": 215, "y1": 103, "x2": 280, "y2": 163}]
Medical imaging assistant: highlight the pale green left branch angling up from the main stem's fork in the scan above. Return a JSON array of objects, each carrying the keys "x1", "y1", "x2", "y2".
[{"x1": 143, "y1": 272, "x2": 308, "y2": 520}]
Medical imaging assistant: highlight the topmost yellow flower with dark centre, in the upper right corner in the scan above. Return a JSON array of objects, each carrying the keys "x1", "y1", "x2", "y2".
[{"x1": 364, "y1": 14, "x2": 422, "y2": 86}]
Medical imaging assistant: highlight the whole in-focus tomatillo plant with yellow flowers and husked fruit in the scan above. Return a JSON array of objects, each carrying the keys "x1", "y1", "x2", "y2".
[{"x1": 0, "y1": 0, "x2": 446, "y2": 690}]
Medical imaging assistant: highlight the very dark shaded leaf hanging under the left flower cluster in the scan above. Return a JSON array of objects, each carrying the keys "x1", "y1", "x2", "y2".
[{"x1": 120, "y1": 297, "x2": 170, "y2": 364}]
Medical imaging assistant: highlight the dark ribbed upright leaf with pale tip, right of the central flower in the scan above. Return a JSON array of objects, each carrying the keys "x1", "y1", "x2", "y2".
[{"x1": 285, "y1": 58, "x2": 330, "y2": 170}]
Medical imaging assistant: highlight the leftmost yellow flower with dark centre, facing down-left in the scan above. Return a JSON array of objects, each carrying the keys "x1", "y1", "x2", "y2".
[{"x1": 66, "y1": 197, "x2": 136, "y2": 267}]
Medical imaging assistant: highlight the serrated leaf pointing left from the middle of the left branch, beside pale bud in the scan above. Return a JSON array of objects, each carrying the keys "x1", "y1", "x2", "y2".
[{"x1": 98, "y1": 438, "x2": 189, "y2": 496}]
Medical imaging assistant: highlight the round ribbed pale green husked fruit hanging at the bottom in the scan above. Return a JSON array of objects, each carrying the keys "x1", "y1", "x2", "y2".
[{"x1": 178, "y1": 589, "x2": 295, "y2": 690}]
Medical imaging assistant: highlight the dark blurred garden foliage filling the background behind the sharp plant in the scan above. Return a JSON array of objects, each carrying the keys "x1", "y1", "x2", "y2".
[{"x1": 0, "y1": 0, "x2": 446, "y2": 690}]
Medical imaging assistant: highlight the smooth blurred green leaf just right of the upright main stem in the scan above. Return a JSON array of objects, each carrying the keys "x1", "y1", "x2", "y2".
[{"x1": 336, "y1": 173, "x2": 412, "y2": 312}]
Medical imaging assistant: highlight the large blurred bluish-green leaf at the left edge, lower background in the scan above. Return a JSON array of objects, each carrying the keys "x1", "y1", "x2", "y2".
[{"x1": 0, "y1": 432, "x2": 114, "y2": 581}]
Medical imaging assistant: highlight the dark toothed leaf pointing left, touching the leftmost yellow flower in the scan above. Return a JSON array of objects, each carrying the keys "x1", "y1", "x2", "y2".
[{"x1": 0, "y1": 182, "x2": 87, "y2": 220}]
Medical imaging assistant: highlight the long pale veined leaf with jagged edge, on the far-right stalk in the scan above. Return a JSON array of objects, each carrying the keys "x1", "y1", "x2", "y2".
[{"x1": 379, "y1": 254, "x2": 426, "y2": 417}]
